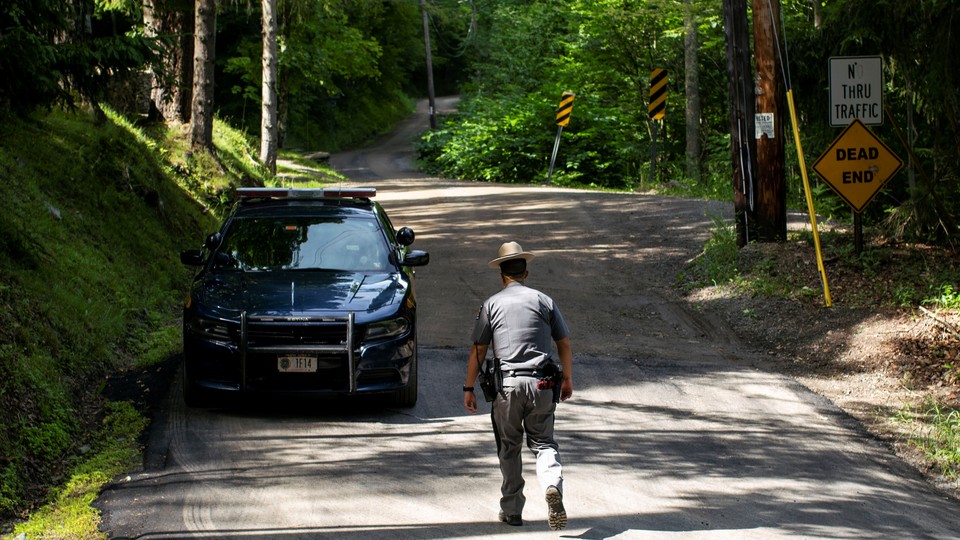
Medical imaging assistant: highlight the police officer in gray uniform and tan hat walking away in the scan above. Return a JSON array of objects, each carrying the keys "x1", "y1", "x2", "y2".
[{"x1": 463, "y1": 242, "x2": 573, "y2": 530}]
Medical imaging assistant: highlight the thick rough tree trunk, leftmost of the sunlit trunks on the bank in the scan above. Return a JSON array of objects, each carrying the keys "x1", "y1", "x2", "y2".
[{"x1": 143, "y1": 0, "x2": 194, "y2": 122}]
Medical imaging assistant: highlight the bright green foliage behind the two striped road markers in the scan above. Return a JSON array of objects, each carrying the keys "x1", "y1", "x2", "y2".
[{"x1": 418, "y1": 0, "x2": 729, "y2": 191}]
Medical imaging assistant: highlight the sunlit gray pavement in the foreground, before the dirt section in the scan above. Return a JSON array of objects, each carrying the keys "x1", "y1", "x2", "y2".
[{"x1": 101, "y1": 349, "x2": 956, "y2": 539}]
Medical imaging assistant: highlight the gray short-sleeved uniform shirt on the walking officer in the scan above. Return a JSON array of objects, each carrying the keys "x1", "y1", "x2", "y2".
[{"x1": 473, "y1": 281, "x2": 570, "y2": 369}]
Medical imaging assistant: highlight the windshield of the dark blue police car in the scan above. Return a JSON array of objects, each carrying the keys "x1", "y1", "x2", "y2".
[{"x1": 214, "y1": 217, "x2": 389, "y2": 272}]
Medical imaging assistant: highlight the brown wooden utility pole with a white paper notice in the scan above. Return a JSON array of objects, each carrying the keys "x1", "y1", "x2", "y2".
[{"x1": 753, "y1": 0, "x2": 787, "y2": 242}]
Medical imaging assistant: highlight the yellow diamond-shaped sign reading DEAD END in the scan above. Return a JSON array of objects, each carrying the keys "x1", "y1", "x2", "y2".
[{"x1": 813, "y1": 119, "x2": 903, "y2": 213}]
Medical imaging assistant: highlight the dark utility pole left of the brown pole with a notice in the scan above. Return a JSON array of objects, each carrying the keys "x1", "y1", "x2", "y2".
[{"x1": 723, "y1": 0, "x2": 756, "y2": 247}]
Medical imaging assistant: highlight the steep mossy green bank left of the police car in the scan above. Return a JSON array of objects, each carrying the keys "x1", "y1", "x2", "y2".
[{"x1": 0, "y1": 107, "x2": 270, "y2": 538}]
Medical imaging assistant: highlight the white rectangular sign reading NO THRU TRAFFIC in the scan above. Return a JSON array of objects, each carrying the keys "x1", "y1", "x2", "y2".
[{"x1": 830, "y1": 56, "x2": 883, "y2": 127}]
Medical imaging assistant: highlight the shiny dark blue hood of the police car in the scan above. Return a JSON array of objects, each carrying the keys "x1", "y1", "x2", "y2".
[{"x1": 194, "y1": 271, "x2": 407, "y2": 316}]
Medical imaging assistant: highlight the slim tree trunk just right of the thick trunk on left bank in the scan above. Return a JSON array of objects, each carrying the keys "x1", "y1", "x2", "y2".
[{"x1": 190, "y1": 0, "x2": 217, "y2": 150}]
